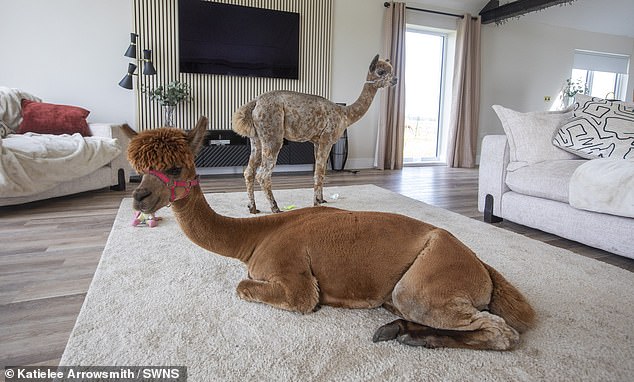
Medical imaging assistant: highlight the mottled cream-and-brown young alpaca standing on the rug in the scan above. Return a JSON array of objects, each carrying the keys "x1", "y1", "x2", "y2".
[{"x1": 233, "y1": 55, "x2": 396, "y2": 214}]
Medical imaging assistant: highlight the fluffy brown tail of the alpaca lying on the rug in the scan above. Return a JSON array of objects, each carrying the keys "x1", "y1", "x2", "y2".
[{"x1": 483, "y1": 263, "x2": 535, "y2": 333}]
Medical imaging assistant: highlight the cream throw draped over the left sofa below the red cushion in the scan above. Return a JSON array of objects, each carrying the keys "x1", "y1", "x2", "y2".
[{"x1": 0, "y1": 133, "x2": 121, "y2": 197}]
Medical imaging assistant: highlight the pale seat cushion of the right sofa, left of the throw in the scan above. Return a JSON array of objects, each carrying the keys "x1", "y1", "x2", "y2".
[{"x1": 506, "y1": 159, "x2": 587, "y2": 203}]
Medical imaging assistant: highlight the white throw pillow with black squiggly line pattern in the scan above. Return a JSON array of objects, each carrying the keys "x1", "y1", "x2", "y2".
[{"x1": 553, "y1": 94, "x2": 634, "y2": 159}]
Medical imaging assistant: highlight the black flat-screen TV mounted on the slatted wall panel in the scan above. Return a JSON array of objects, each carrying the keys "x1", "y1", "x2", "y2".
[{"x1": 178, "y1": 0, "x2": 299, "y2": 79}]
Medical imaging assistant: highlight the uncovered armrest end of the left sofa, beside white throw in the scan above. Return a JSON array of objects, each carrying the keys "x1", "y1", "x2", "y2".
[{"x1": 88, "y1": 123, "x2": 132, "y2": 190}]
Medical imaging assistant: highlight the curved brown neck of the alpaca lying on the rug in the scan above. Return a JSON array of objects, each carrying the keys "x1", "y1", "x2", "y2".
[{"x1": 172, "y1": 187, "x2": 260, "y2": 263}]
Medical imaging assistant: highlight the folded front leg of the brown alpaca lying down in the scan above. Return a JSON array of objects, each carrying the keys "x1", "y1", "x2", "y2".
[{"x1": 237, "y1": 275, "x2": 319, "y2": 314}]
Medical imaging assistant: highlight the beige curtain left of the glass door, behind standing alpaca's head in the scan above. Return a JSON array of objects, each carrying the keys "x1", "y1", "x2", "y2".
[{"x1": 374, "y1": 2, "x2": 405, "y2": 170}]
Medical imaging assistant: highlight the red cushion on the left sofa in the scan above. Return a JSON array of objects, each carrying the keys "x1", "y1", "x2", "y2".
[{"x1": 18, "y1": 99, "x2": 91, "y2": 137}]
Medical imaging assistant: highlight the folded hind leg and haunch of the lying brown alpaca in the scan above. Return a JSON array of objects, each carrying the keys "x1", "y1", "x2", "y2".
[{"x1": 373, "y1": 231, "x2": 519, "y2": 350}]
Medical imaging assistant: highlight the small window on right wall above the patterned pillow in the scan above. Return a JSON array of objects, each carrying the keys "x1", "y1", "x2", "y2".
[{"x1": 571, "y1": 50, "x2": 630, "y2": 100}]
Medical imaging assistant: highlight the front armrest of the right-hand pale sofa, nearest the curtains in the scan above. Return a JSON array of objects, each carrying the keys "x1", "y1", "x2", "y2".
[{"x1": 478, "y1": 135, "x2": 510, "y2": 216}]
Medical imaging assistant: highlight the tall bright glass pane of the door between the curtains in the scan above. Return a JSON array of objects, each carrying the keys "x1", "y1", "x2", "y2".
[{"x1": 403, "y1": 30, "x2": 445, "y2": 164}]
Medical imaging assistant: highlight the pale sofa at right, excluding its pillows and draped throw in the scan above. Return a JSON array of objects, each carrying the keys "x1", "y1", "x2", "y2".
[{"x1": 478, "y1": 135, "x2": 634, "y2": 258}]
